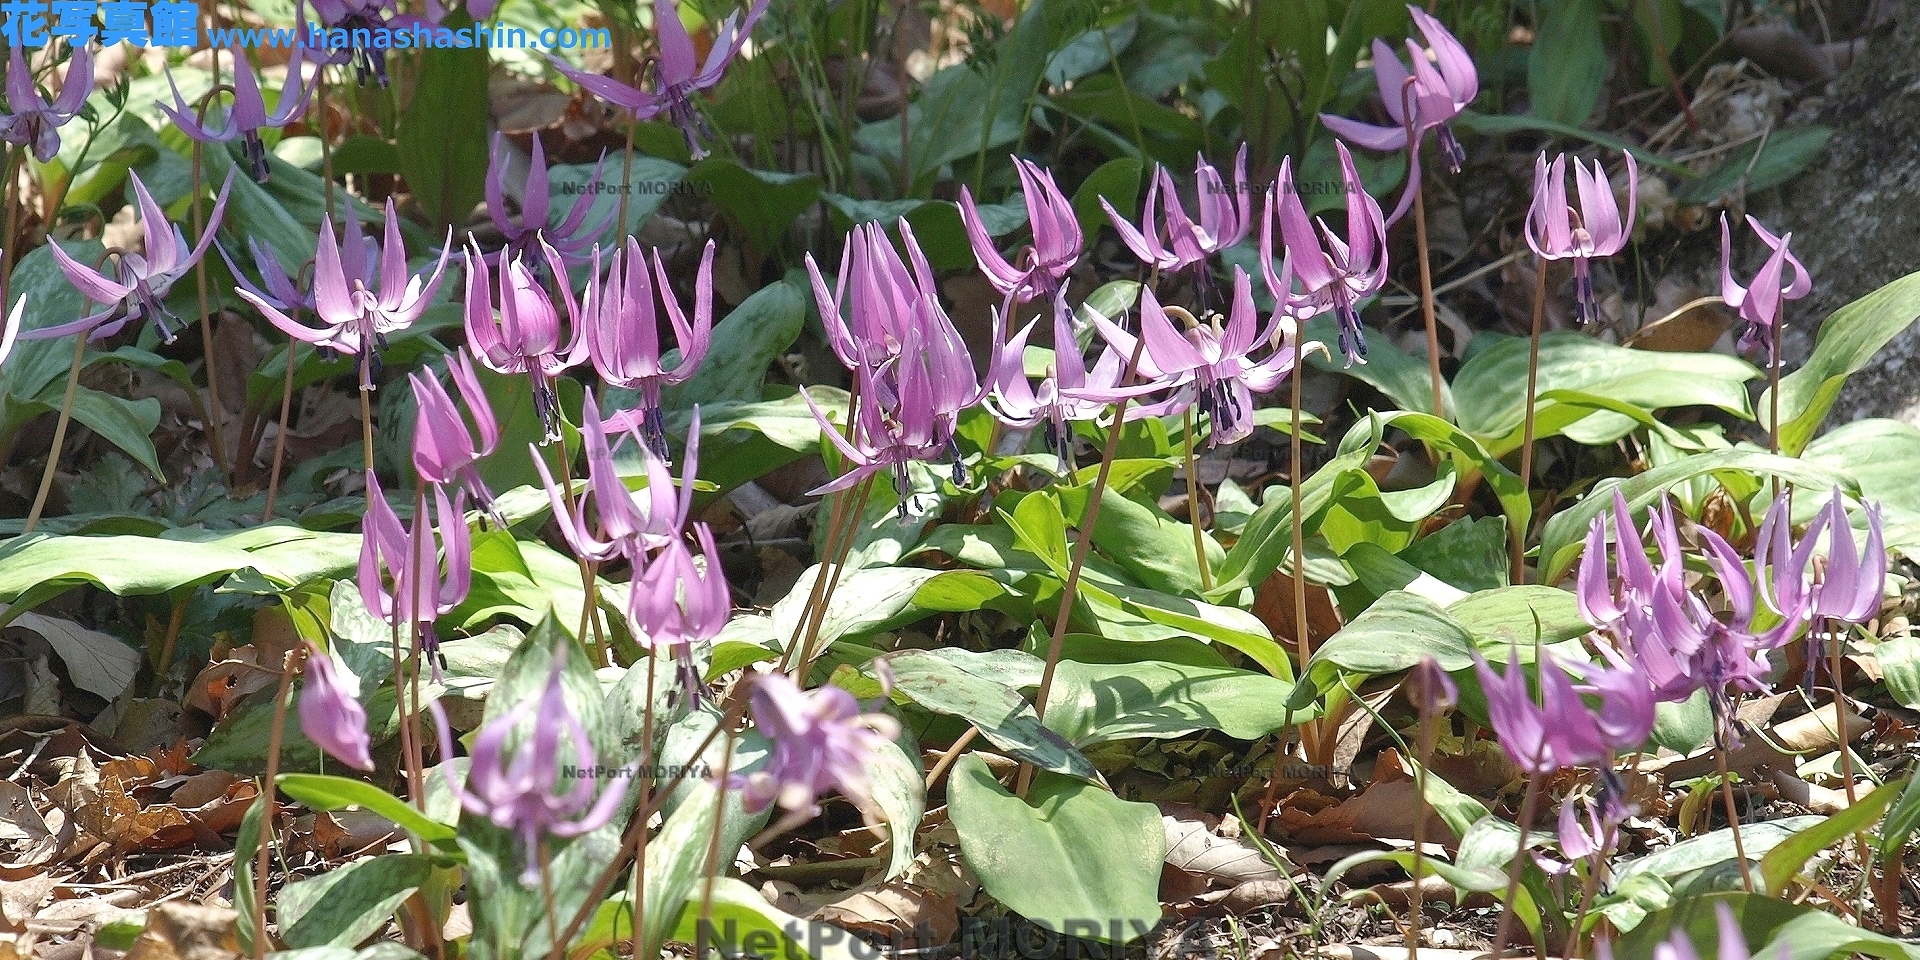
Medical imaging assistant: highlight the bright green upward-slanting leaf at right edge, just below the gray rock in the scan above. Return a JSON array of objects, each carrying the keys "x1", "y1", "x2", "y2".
[{"x1": 1755, "y1": 273, "x2": 1920, "y2": 455}]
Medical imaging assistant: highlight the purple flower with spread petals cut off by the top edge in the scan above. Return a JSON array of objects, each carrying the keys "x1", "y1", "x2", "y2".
[{"x1": 547, "y1": 0, "x2": 768, "y2": 159}]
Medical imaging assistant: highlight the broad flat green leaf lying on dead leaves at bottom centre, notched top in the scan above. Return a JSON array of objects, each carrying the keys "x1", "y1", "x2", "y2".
[{"x1": 947, "y1": 753, "x2": 1167, "y2": 943}]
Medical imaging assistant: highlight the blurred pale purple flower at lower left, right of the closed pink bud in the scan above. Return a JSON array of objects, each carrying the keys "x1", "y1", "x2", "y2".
[{"x1": 428, "y1": 643, "x2": 634, "y2": 887}]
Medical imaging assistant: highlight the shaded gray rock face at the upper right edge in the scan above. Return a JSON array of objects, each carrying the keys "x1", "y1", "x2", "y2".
[{"x1": 1782, "y1": 14, "x2": 1920, "y2": 424}]
